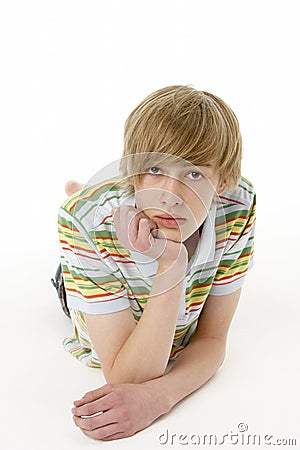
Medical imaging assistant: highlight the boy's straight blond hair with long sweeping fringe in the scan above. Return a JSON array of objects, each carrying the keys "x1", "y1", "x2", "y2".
[{"x1": 120, "y1": 85, "x2": 242, "y2": 191}]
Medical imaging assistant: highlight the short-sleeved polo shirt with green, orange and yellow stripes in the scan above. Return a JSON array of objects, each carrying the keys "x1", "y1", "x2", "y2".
[{"x1": 58, "y1": 177, "x2": 255, "y2": 367}]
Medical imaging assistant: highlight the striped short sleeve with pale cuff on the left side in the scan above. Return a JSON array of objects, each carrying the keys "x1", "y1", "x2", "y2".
[{"x1": 58, "y1": 208, "x2": 130, "y2": 314}]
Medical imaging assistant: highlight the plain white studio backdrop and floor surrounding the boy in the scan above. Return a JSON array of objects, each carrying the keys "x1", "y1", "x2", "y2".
[{"x1": 0, "y1": 0, "x2": 300, "y2": 450}]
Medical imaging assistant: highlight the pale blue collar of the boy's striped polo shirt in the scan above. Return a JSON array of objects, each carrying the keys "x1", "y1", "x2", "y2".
[{"x1": 122, "y1": 194, "x2": 217, "y2": 278}]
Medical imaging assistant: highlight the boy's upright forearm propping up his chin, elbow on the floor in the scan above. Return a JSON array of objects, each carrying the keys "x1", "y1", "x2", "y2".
[{"x1": 106, "y1": 266, "x2": 186, "y2": 383}]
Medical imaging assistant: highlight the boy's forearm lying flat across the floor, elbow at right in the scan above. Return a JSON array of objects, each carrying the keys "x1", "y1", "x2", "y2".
[{"x1": 147, "y1": 338, "x2": 226, "y2": 414}]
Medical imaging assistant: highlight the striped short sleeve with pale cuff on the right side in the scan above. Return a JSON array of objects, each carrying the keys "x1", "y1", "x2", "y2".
[{"x1": 210, "y1": 194, "x2": 256, "y2": 295}]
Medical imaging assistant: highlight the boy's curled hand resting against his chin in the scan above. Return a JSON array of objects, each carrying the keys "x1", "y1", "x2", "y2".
[{"x1": 112, "y1": 205, "x2": 187, "y2": 266}]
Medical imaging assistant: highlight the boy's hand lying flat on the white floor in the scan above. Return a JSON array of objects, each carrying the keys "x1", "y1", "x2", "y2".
[{"x1": 72, "y1": 382, "x2": 168, "y2": 441}]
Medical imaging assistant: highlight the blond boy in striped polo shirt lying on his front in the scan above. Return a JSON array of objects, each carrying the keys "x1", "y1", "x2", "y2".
[{"x1": 51, "y1": 86, "x2": 255, "y2": 440}]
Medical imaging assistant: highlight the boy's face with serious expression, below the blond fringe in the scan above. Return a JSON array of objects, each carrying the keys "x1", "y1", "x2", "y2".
[{"x1": 135, "y1": 160, "x2": 225, "y2": 242}]
